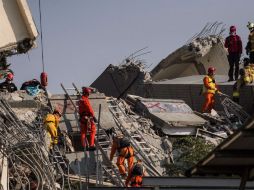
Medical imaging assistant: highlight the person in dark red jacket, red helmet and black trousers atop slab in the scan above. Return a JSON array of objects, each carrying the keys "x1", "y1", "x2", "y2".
[{"x1": 224, "y1": 26, "x2": 242, "y2": 81}]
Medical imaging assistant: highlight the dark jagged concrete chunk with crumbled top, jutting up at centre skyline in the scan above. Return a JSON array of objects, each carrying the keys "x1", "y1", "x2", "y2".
[{"x1": 91, "y1": 55, "x2": 151, "y2": 98}]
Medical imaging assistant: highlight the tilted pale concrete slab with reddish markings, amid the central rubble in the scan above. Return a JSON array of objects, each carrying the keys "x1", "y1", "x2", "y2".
[{"x1": 127, "y1": 95, "x2": 206, "y2": 135}]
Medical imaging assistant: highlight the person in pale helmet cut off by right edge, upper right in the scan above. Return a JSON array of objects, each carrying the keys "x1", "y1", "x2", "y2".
[{"x1": 245, "y1": 22, "x2": 254, "y2": 63}]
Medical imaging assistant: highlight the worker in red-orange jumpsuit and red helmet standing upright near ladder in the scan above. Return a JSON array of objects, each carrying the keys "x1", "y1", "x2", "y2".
[{"x1": 79, "y1": 87, "x2": 97, "y2": 151}]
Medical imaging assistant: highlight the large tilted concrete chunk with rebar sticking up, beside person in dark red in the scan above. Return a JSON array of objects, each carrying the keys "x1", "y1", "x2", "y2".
[{"x1": 150, "y1": 22, "x2": 228, "y2": 81}]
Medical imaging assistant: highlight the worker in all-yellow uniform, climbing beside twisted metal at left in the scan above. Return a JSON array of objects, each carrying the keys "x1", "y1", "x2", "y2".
[{"x1": 44, "y1": 108, "x2": 62, "y2": 149}]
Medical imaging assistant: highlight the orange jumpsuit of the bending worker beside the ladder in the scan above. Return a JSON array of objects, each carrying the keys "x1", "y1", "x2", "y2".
[{"x1": 110, "y1": 139, "x2": 134, "y2": 176}]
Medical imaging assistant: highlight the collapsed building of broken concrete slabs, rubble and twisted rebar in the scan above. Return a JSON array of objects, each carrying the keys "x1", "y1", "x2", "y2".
[{"x1": 0, "y1": 0, "x2": 252, "y2": 190}]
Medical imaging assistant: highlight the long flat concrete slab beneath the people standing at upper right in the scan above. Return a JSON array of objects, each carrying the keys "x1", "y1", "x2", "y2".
[{"x1": 136, "y1": 75, "x2": 254, "y2": 114}]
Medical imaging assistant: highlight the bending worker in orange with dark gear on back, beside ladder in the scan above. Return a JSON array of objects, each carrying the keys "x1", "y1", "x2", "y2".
[{"x1": 110, "y1": 135, "x2": 134, "y2": 178}]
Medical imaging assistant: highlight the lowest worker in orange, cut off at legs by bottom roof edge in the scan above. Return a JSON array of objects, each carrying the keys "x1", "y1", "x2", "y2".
[{"x1": 125, "y1": 160, "x2": 145, "y2": 187}]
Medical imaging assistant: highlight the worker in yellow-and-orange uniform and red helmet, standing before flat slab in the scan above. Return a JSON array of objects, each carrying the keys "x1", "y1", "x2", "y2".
[{"x1": 202, "y1": 67, "x2": 220, "y2": 113}]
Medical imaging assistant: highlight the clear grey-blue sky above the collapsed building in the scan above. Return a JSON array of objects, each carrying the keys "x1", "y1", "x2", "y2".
[{"x1": 8, "y1": 0, "x2": 254, "y2": 93}]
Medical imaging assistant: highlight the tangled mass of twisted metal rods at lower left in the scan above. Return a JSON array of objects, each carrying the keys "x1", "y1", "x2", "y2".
[{"x1": 0, "y1": 99, "x2": 56, "y2": 190}]
